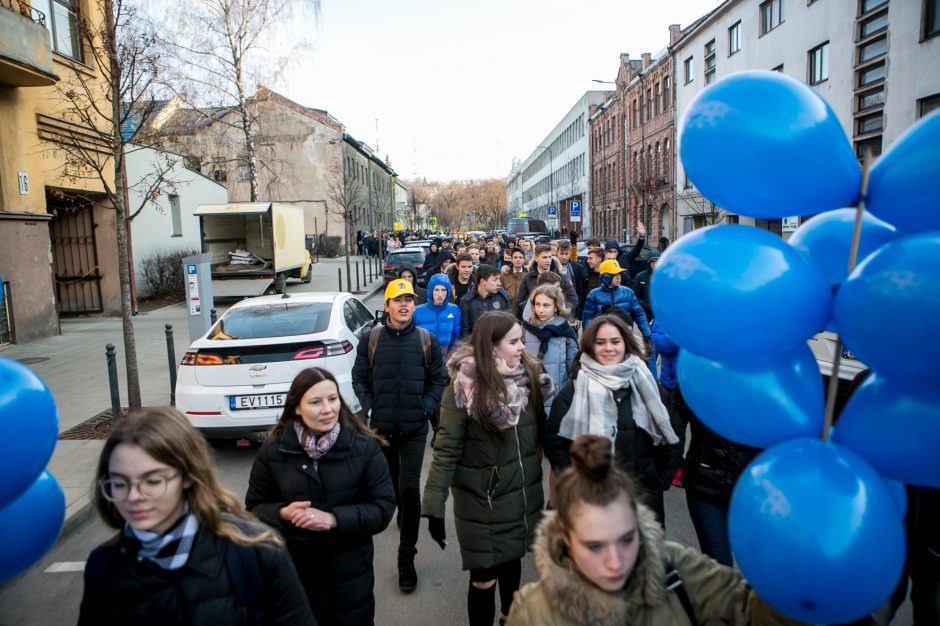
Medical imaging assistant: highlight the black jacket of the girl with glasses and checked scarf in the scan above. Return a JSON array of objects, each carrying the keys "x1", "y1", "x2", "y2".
[{"x1": 78, "y1": 524, "x2": 316, "y2": 626}]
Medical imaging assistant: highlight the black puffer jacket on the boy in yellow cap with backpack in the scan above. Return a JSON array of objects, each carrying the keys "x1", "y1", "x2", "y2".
[{"x1": 352, "y1": 320, "x2": 448, "y2": 433}]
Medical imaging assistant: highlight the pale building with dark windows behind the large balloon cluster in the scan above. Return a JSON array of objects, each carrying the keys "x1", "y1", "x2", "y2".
[{"x1": 670, "y1": 0, "x2": 940, "y2": 236}]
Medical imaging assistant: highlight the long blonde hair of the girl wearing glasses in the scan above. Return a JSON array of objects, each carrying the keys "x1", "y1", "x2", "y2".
[{"x1": 94, "y1": 407, "x2": 284, "y2": 546}]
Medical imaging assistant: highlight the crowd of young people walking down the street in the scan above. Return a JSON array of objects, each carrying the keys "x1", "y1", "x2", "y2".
[{"x1": 80, "y1": 229, "x2": 936, "y2": 626}]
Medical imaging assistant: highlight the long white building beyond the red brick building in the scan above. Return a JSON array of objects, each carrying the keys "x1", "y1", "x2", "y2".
[{"x1": 506, "y1": 91, "x2": 609, "y2": 236}]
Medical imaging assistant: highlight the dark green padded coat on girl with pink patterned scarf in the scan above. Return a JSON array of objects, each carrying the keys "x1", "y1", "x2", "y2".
[{"x1": 421, "y1": 386, "x2": 544, "y2": 569}]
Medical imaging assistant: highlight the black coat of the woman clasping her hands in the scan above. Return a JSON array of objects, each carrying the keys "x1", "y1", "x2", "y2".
[{"x1": 246, "y1": 427, "x2": 395, "y2": 626}]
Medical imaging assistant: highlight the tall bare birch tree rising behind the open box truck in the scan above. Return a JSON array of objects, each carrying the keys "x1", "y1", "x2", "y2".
[{"x1": 162, "y1": 0, "x2": 320, "y2": 202}]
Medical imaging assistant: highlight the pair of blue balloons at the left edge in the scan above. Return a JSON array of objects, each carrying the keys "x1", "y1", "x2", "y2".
[{"x1": 0, "y1": 357, "x2": 65, "y2": 580}]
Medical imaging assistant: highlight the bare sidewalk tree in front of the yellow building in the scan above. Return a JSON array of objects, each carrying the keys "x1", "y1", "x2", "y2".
[{"x1": 56, "y1": 0, "x2": 180, "y2": 410}]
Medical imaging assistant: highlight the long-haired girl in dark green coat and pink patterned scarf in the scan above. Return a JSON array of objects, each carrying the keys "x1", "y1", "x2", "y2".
[{"x1": 422, "y1": 311, "x2": 553, "y2": 626}]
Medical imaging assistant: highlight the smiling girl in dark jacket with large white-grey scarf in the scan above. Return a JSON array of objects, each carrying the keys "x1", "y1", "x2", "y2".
[{"x1": 545, "y1": 314, "x2": 682, "y2": 523}]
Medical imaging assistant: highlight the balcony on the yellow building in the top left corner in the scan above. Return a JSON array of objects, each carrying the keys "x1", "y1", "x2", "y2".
[{"x1": 0, "y1": 0, "x2": 59, "y2": 87}]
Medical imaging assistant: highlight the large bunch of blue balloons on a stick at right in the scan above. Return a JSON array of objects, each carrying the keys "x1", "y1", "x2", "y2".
[{"x1": 650, "y1": 72, "x2": 940, "y2": 623}]
